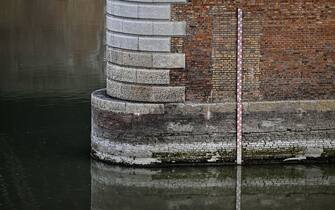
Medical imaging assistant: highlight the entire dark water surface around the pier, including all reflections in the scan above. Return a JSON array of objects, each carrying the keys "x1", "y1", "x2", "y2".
[{"x1": 0, "y1": 0, "x2": 335, "y2": 210}]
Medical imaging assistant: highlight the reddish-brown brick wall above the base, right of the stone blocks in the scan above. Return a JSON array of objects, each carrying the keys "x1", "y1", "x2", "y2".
[{"x1": 171, "y1": 0, "x2": 335, "y2": 102}]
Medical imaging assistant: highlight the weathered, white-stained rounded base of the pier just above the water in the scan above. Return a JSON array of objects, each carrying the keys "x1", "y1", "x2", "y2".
[{"x1": 91, "y1": 89, "x2": 335, "y2": 166}]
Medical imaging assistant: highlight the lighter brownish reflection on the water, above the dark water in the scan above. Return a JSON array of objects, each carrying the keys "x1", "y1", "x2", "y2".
[{"x1": 0, "y1": 0, "x2": 104, "y2": 100}]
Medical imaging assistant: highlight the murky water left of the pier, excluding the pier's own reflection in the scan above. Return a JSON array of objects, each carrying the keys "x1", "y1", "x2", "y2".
[{"x1": 0, "y1": 0, "x2": 105, "y2": 210}]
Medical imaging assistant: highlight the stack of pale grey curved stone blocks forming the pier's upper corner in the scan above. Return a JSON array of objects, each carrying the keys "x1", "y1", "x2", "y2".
[{"x1": 106, "y1": 0, "x2": 186, "y2": 104}]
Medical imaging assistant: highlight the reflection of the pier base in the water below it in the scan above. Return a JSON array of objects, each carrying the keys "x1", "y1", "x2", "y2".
[{"x1": 91, "y1": 161, "x2": 335, "y2": 210}]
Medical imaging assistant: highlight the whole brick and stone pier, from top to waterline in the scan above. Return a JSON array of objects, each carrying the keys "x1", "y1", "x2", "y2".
[{"x1": 91, "y1": 0, "x2": 335, "y2": 165}]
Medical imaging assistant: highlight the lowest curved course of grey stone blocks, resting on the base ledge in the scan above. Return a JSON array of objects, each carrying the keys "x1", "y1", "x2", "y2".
[{"x1": 107, "y1": 78, "x2": 185, "y2": 103}]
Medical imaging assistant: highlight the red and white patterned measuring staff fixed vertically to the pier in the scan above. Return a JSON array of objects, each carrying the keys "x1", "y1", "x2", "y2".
[{"x1": 236, "y1": 9, "x2": 243, "y2": 165}]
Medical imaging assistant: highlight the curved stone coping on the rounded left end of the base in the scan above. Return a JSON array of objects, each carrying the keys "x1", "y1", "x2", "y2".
[{"x1": 91, "y1": 89, "x2": 164, "y2": 115}]
